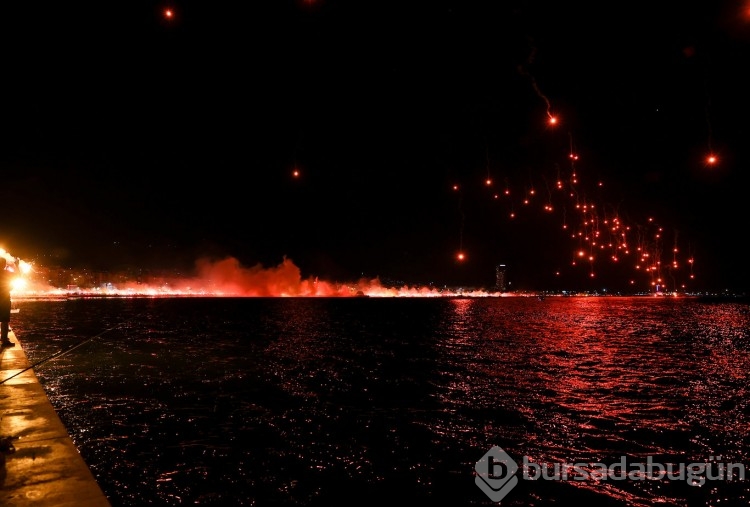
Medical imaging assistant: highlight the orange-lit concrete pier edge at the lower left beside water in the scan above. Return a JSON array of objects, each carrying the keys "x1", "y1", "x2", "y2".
[{"x1": 0, "y1": 331, "x2": 110, "y2": 507}]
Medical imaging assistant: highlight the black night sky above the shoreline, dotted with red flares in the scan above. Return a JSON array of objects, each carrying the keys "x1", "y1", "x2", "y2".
[{"x1": 0, "y1": 0, "x2": 750, "y2": 290}]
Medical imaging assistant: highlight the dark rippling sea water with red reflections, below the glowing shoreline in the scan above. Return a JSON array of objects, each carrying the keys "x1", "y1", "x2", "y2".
[{"x1": 5, "y1": 297, "x2": 750, "y2": 506}]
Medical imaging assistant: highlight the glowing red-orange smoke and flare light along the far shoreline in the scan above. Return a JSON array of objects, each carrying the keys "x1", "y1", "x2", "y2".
[{"x1": 13, "y1": 257, "x2": 501, "y2": 297}]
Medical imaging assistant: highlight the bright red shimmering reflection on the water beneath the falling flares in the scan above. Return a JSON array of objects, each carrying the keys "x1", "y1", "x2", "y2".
[{"x1": 437, "y1": 297, "x2": 750, "y2": 505}]
